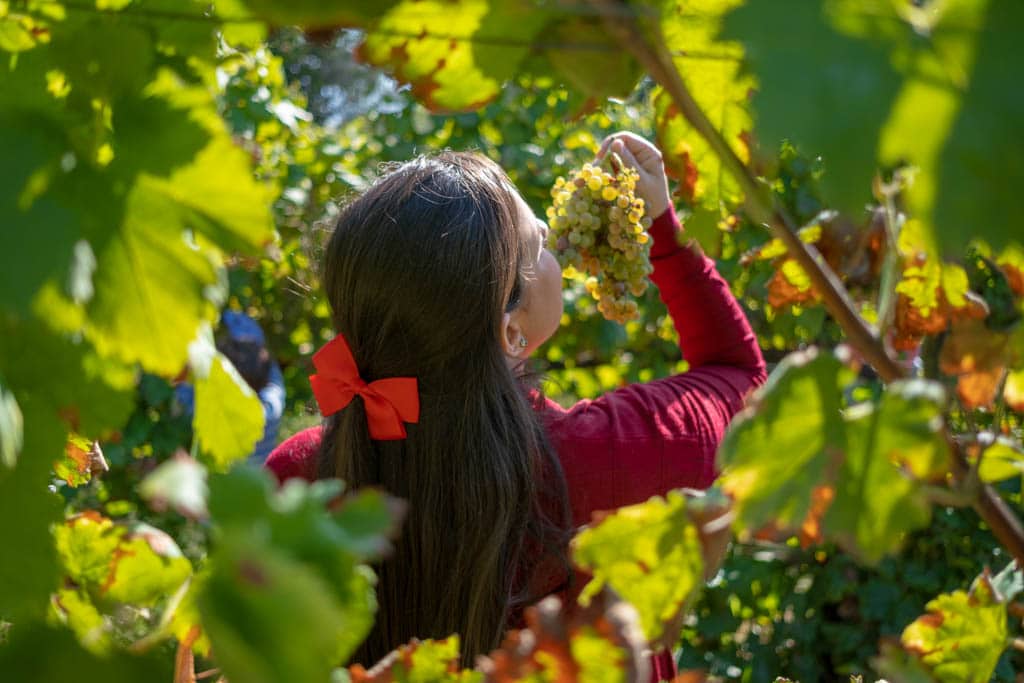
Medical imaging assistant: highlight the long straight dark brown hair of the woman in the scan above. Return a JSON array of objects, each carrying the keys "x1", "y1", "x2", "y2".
[{"x1": 318, "y1": 152, "x2": 569, "y2": 667}]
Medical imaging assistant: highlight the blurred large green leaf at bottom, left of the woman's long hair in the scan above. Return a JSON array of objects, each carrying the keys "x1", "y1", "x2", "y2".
[{"x1": 197, "y1": 468, "x2": 394, "y2": 681}]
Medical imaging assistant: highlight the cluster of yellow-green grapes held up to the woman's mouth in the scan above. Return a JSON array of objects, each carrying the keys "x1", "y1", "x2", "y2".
[{"x1": 548, "y1": 160, "x2": 651, "y2": 323}]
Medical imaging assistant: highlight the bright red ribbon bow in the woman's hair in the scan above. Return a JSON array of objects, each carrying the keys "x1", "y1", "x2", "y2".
[{"x1": 309, "y1": 334, "x2": 420, "y2": 441}]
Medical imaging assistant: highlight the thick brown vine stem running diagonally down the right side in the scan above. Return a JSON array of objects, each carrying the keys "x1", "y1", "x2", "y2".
[{"x1": 588, "y1": 0, "x2": 1024, "y2": 565}]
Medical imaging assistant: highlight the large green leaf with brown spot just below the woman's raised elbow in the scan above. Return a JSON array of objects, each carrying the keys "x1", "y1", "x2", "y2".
[{"x1": 719, "y1": 352, "x2": 949, "y2": 564}]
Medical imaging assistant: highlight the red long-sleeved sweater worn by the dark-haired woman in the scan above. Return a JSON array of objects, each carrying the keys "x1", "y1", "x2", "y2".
[{"x1": 266, "y1": 209, "x2": 765, "y2": 680}]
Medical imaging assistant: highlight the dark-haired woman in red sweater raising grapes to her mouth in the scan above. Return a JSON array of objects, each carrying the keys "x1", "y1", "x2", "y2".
[{"x1": 267, "y1": 133, "x2": 765, "y2": 677}]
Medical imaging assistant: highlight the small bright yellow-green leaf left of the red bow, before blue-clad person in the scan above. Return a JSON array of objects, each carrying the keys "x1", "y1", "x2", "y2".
[{"x1": 193, "y1": 352, "x2": 264, "y2": 471}]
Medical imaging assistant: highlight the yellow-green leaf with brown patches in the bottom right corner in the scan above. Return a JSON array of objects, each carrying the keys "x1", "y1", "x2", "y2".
[{"x1": 900, "y1": 569, "x2": 1008, "y2": 683}]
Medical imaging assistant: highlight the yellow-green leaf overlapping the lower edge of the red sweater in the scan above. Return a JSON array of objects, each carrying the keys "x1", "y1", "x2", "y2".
[{"x1": 572, "y1": 492, "x2": 703, "y2": 641}]
